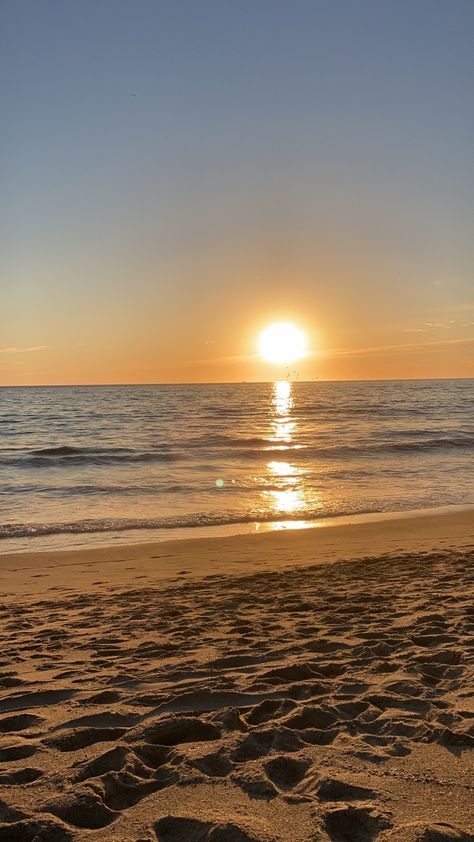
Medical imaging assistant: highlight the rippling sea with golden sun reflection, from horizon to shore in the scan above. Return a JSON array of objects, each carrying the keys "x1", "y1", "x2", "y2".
[{"x1": 0, "y1": 380, "x2": 474, "y2": 552}]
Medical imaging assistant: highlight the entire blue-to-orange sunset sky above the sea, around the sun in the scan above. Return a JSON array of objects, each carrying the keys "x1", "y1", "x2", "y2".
[{"x1": 0, "y1": 0, "x2": 474, "y2": 385}]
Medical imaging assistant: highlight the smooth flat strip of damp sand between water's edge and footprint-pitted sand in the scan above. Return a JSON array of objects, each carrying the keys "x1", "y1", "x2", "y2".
[{"x1": 0, "y1": 507, "x2": 474, "y2": 592}]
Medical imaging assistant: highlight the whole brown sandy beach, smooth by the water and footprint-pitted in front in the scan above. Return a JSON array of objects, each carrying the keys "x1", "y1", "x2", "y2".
[{"x1": 0, "y1": 512, "x2": 474, "y2": 842}]
